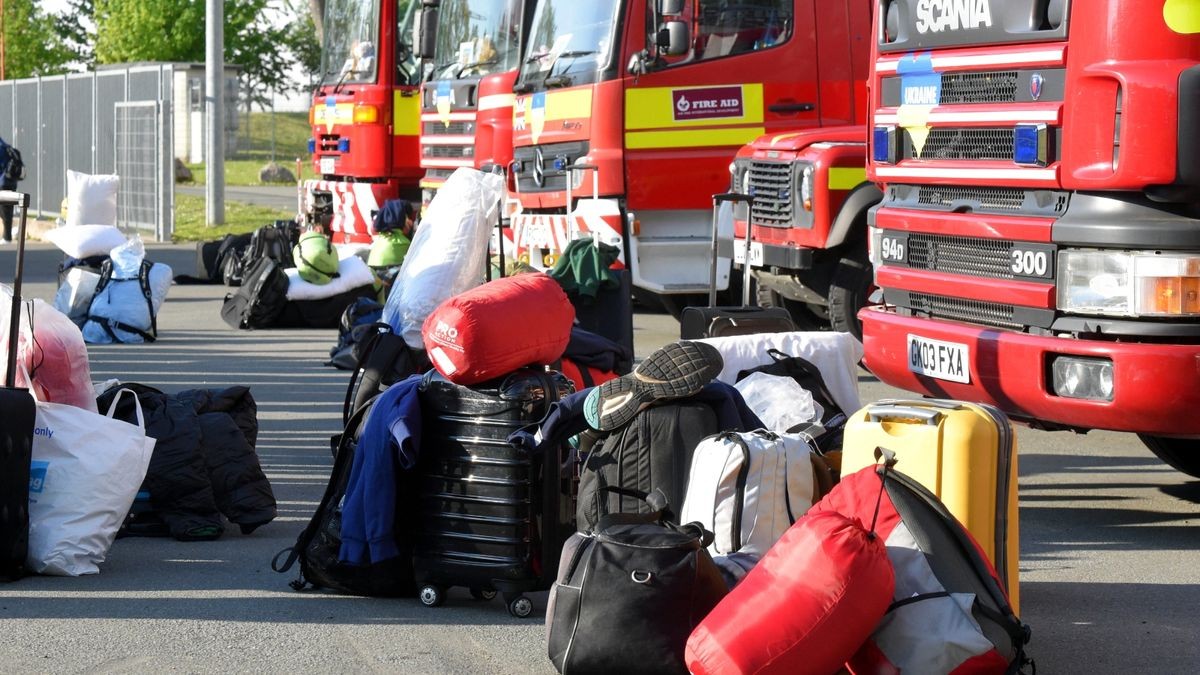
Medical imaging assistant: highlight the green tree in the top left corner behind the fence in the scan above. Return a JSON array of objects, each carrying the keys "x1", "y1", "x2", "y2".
[{"x1": 0, "y1": 0, "x2": 72, "y2": 79}]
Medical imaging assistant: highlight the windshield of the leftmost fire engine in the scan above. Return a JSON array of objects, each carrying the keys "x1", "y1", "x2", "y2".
[{"x1": 320, "y1": 0, "x2": 379, "y2": 84}]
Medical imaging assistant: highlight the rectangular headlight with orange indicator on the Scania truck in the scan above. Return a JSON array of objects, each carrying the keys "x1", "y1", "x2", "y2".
[{"x1": 1058, "y1": 251, "x2": 1200, "y2": 317}]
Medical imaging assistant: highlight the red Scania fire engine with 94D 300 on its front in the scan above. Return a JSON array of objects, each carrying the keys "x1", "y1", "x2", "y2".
[{"x1": 860, "y1": 0, "x2": 1200, "y2": 476}]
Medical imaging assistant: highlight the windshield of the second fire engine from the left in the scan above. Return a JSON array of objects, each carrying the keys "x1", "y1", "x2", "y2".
[{"x1": 433, "y1": 0, "x2": 522, "y2": 79}]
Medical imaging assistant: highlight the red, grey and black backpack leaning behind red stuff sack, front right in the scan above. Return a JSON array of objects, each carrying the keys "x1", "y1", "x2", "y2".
[{"x1": 809, "y1": 460, "x2": 1030, "y2": 675}]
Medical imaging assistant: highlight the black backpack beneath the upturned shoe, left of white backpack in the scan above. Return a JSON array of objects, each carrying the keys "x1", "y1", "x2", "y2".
[{"x1": 576, "y1": 401, "x2": 720, "y2": 531}]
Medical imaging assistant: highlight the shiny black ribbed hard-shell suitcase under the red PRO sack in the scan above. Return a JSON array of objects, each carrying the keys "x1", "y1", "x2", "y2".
[{"x1": 413, "y1": 369, "x2": 575, "y2": 617}]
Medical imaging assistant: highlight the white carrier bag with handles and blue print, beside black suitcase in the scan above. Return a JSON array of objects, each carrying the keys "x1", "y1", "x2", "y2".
[{"x1": 26, "y1": 389, "x2": 155, "y2": 577}]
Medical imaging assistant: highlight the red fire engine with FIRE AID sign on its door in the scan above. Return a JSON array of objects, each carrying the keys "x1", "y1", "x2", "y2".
[{"x1": 509, "y1": 0, "x2": 866, "y2": 314}]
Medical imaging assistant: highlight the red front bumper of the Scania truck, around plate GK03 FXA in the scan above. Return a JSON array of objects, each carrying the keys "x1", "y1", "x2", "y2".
[{"x1": 858, "y1": 307, "x2": 1200, "y2": 436}]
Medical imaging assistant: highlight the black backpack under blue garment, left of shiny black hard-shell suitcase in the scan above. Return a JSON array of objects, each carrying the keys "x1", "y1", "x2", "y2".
[{"x1": 271, "y1": 393, "x2": 416, "y2": 597}]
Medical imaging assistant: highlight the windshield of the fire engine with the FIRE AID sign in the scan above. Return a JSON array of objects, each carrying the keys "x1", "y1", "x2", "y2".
[{"x1": 521, "y1": 0, "x2": 620, "y2": 88}]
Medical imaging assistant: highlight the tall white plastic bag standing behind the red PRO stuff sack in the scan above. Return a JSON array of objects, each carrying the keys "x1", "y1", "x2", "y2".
[{"x1": 383, "y1": 168, "x2": 504, "y2": 350}]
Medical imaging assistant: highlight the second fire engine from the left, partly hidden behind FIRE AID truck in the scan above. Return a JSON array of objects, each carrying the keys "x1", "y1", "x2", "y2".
[{"x1": 418, "y1": 0, "x2": 535, "y2": 205}]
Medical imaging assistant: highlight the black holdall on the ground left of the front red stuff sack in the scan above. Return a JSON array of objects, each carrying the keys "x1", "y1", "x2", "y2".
[{"x1": 546, "y1": 491, "x2": 728, "y2": 674}]
